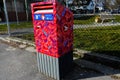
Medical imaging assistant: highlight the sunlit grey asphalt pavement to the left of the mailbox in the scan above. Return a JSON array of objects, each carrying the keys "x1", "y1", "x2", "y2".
[{"x1": 0, "y1": 42, "x2": 53, "y2": 80}]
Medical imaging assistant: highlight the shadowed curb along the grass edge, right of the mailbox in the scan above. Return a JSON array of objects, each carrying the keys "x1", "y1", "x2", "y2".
[{"x1": 74, "y1": 49, "x2": 120, "y2": 69}]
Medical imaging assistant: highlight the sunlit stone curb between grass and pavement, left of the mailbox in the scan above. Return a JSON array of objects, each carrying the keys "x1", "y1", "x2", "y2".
[{"x1": 0, "y1": 37, "x2": 36, "y2": 53}]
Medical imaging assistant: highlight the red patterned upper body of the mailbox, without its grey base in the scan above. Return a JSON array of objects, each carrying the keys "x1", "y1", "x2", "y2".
[{"x1": 32, "y1": 2, "x2": 73, "y2": 57}]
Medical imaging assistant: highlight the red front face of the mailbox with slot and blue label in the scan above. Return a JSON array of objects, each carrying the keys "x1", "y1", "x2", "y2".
[{"x1": 32, "y1": 2, "x2": 58, "y2": 57}]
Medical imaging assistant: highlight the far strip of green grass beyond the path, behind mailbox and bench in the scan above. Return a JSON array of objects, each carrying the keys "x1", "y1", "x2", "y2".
[{"x1": 0, "y1": 15, "x2": 120, "y2": 32}]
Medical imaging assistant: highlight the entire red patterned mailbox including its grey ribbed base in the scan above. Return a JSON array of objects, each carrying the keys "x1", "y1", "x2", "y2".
[{"x1": 31, "y1": 1, "x2": 73, "y2": 79}]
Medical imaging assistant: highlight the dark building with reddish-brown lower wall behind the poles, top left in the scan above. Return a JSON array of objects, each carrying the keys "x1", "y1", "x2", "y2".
[{"x1": 0, "y1": 0, "x2": 41, "y2": 21}]
